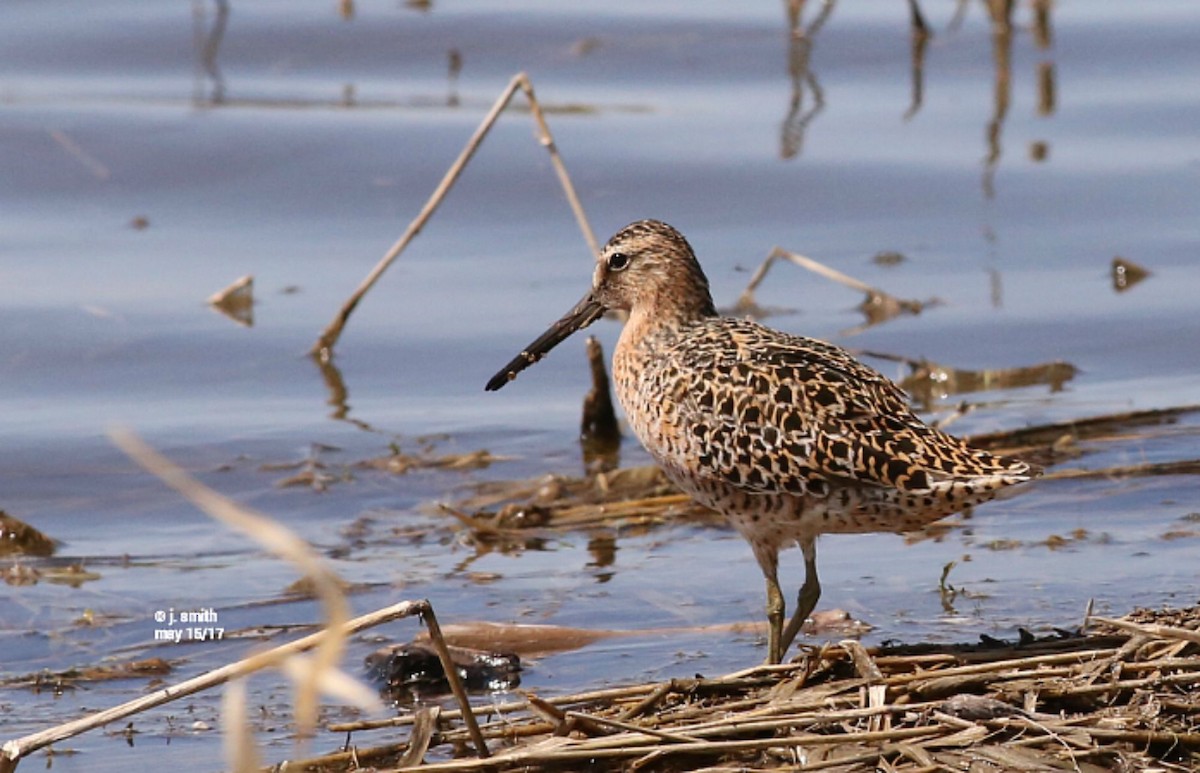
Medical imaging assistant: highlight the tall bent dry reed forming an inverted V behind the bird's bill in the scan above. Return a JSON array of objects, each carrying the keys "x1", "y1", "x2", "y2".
[{"x1": 311, "y1": 72, "x2": 600, "y2": 362}]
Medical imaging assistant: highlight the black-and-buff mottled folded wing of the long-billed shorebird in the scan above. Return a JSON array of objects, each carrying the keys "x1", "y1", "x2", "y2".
[{"x1": 672, "y1": 318, "x2": 1000, "y2": 497}]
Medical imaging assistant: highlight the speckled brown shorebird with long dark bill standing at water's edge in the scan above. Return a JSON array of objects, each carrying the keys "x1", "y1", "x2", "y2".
[{"x1": 487, "y1": 220, "x2": 1038, "y2": 663}]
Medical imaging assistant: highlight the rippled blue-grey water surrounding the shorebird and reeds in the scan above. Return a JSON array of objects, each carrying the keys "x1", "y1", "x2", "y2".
[{"x1": 0, "y1": 0, "x2": 1200, "y2": 771}]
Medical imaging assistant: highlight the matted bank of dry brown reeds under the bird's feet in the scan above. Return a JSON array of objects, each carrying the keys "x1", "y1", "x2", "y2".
[{"x1": 316, "y1": 610, "x2": 1200, "y2": 772}]
